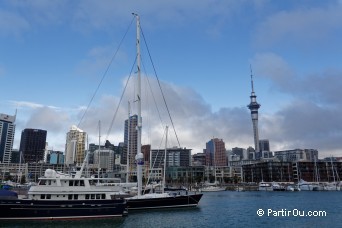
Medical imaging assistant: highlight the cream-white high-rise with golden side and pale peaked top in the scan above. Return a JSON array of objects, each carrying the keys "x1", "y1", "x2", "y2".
[{"x1": 64, "y1": 125, "x2": 87, "y2": 165}]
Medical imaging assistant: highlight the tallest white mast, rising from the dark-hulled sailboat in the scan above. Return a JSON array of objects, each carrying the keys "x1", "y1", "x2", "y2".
[{"x1": 133, "y1": 13, "x2": 144, "y2": 196}]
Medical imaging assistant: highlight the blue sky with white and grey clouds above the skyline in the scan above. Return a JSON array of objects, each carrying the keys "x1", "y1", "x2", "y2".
[{"x1": 0, "y1": 0, "x2": 342, "y2": 158}]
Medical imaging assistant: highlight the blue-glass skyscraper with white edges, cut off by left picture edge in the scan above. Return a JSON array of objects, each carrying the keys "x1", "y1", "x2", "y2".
[{"x1": 0, "y1": 113, "x2": 16, "y2": 163}]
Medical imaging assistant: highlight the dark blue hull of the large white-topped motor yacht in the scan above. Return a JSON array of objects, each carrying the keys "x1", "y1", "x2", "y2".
[{"x1": 0, "y1": 199, "x2": 127, "y2": 220}]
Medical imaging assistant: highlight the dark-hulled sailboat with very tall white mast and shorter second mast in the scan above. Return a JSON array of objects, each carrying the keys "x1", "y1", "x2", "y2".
[{"x1": 126, "y1": 14, "x2": 203, "y2": 210}]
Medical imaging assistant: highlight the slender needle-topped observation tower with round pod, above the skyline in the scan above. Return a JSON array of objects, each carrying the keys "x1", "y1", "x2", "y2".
[{"x1": 247, "y1": 67, "x2": 260, "y2": 152}]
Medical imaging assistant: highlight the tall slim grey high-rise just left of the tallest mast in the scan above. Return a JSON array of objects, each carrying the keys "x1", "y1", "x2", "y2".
[{"x1": 121, "y1": 115, "x2": 138, "y2": 166}]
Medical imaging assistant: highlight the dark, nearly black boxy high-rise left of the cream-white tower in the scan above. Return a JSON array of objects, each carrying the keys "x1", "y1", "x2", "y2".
[{"x1": 19, "y1": 128, "x2": 47, "y2": 163}]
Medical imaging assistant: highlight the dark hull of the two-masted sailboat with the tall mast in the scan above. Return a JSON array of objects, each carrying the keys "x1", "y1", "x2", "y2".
[{"x1": 127, "y1": 194, "x2": 203, "y2": 211}]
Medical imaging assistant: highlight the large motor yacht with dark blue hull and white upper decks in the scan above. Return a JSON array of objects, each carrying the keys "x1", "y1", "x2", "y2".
[{"x1": 0, "y1": 154, "x2": 127, "y2": 220}]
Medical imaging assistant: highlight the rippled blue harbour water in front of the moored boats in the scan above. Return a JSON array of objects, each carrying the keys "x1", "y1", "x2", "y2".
[{"x1": 0, "y1": 191, "x2": 342, "y2": 228}]
